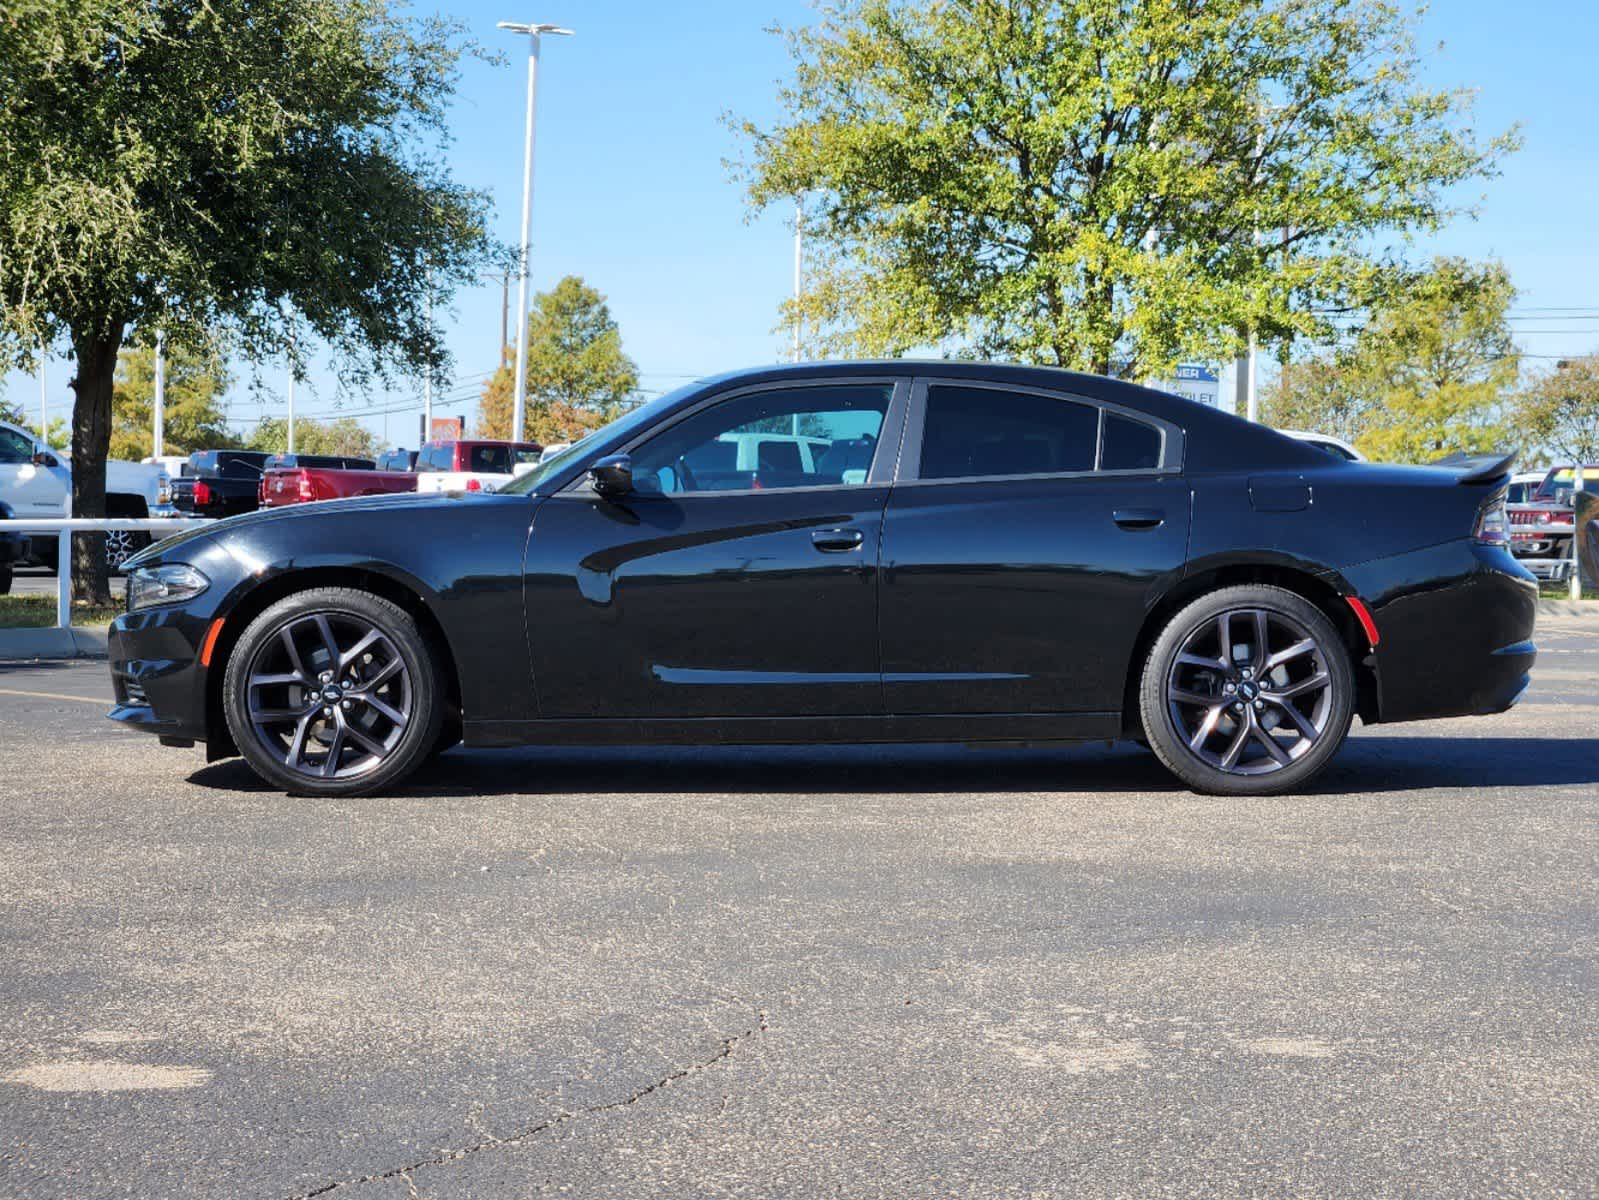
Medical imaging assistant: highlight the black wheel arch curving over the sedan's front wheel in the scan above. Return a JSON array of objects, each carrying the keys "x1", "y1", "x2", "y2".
[{"x1": 205, "y1": 566, "x2": 461, "y2": 762}]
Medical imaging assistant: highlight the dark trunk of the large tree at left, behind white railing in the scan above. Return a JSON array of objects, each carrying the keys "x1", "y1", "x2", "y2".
[{"x1": 72, "y1": 320, "x2": 123, "y2": 605}]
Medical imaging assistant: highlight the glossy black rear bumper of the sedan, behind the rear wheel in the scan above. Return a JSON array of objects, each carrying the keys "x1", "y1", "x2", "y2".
[{"x1": 1345, "y1": 539, "x2": 1538, "y2": 722}]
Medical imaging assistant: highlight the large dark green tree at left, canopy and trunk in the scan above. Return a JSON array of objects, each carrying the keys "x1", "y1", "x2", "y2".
[{"x1": 0, "y1": 0, "x2": 491, "y2": 600}]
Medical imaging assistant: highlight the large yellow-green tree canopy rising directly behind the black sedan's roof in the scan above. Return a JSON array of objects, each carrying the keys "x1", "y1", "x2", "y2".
[{"x1": 734, "y1": 0, "x2": 1514, "y2": 378}]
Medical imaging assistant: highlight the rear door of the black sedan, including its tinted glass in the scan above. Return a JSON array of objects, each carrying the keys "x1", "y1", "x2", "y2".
[{"x1": 879, "y1": 379, "x2": 1191, "y2": 714}]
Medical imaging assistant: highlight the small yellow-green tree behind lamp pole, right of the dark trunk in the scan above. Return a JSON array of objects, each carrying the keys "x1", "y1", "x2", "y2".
[{"x1": 110, "y1": 346, "x2": 238, "y2": 461}]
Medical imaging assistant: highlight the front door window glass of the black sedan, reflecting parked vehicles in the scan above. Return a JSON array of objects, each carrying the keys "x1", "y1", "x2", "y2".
[{"x1": 632, "y1": 384, "x2": 894, "y2": 494}]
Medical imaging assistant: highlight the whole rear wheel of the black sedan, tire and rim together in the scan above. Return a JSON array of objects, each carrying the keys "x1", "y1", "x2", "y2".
[{"x1": 1138, "y1": 584, "x2": 1354, "y2": 795}]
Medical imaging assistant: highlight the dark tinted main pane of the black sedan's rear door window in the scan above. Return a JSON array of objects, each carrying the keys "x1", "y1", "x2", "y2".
[{"x1": 921, "y1": 387, "x2": 1099, "y2": 478}]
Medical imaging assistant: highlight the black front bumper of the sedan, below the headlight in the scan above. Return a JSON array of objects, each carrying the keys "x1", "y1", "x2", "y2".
[{"x1": 106, "y1": 608, "x2": 208, "y2": 741}]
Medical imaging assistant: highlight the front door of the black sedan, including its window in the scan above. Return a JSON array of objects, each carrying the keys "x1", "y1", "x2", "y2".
[{"x1": 526, "y1": 379, "x2": 905, "y2": 718}]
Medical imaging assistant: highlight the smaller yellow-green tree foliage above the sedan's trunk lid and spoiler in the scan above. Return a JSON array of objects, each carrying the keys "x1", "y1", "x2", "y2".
[{"x1": 1263, "y1": 258, "x2": 1521, "y2": 462}]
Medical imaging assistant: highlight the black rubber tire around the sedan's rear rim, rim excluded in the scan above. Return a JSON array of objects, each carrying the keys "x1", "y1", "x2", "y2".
[{"x1": 1138, "y1": 584, "x2": 1354, "y2": 795}]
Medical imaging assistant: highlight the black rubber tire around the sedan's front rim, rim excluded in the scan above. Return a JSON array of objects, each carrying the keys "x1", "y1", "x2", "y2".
[{"x1": 222, "y1": 587, "x2": 443, "y2": 797}]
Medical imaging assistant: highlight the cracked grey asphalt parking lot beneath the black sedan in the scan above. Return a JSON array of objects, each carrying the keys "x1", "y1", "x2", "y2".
[{"x1": 0, "y1": 619, "x2": 1599, "y2": 1200}]
